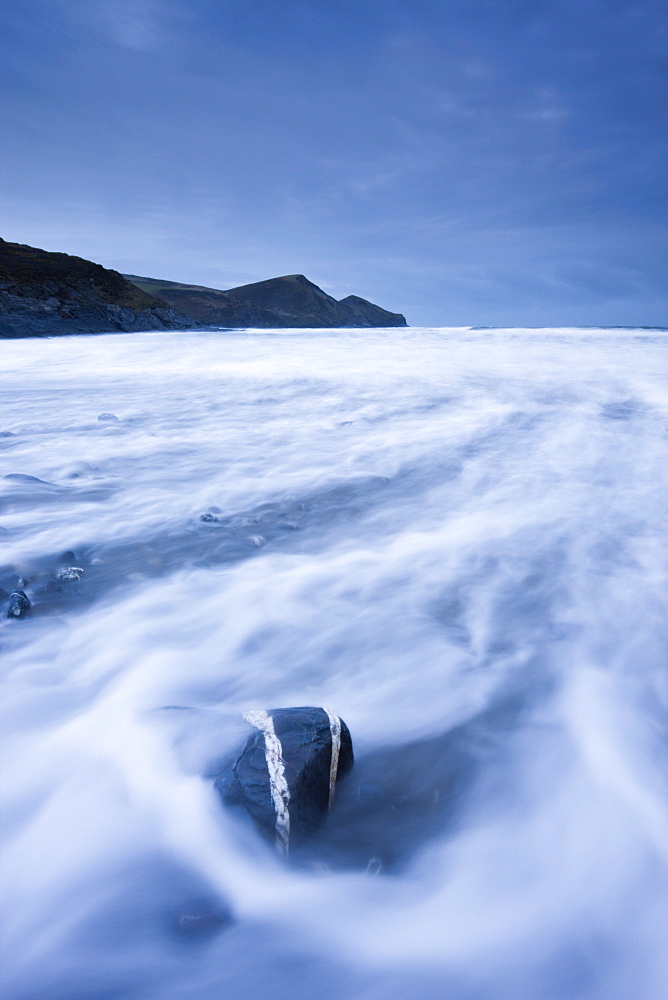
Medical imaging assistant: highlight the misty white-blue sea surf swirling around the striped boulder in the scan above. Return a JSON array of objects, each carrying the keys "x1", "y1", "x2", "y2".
[{"x1": 0, "y1": 329, "x2": 668, "y2": 1000}]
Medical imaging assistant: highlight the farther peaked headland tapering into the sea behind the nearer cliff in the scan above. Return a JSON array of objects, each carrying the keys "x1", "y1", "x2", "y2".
[{"x1": 124, "y1": 274, "x2": 407, "y2": 328}]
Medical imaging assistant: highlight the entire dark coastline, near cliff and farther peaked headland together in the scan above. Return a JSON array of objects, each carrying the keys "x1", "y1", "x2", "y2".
[{"x1": 0, "y1": 239, "x2": 407, "y2": 338}]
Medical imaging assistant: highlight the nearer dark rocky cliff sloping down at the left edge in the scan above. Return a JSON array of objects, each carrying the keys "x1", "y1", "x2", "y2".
[{"x1": 0, "y1": 239, "x2": 195, "y2": 338}]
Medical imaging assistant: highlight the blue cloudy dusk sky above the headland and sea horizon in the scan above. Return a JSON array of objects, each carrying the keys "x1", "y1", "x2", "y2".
[{"x1": 0, "y1": 0, "x2": 668, "y2": 326}]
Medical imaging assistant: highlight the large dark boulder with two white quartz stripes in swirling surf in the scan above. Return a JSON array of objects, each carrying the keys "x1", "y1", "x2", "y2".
[{"x1": 215, "y1": 707, "x2": 353, "y2": 854}]
